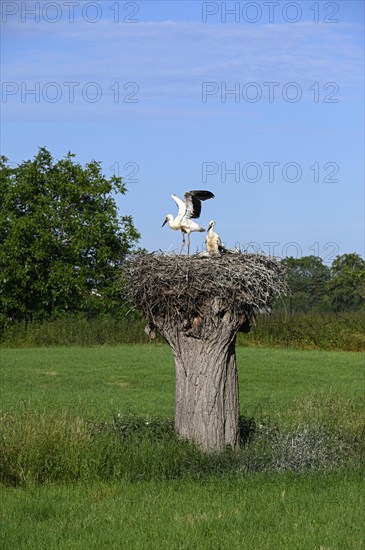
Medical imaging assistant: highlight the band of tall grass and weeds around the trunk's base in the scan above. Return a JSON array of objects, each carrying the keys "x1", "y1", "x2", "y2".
[{"x1": 0, "y1": 404, "x2": 365, "y2": 486}]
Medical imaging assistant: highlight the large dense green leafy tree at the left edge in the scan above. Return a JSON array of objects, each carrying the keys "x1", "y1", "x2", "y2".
[{"x1": 0, "y1": 148, "x2": 139, "y2": 323}]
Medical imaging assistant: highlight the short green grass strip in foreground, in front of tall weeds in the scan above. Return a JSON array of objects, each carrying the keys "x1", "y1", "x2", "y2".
[{"x1": 1, "y1": 473, "x2": 364, "y2": 550}]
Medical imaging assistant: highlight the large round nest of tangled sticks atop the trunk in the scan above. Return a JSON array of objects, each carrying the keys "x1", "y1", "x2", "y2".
[{"x1": 125, "y1": 253, "x2": 287, "y2": 324}]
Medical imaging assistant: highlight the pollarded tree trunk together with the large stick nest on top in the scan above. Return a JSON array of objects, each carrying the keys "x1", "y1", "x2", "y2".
[{"x1": 125, "y1": 252, "x2": 286, "y2": 452}]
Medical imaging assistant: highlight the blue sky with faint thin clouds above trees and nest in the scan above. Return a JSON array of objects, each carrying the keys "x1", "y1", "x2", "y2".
[{"x1": 1, "y1": 0, "x2": 364, "y2": 263}]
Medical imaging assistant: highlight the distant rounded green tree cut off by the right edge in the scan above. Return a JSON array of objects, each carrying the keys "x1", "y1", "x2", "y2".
[{"x1": 327, "y1": 253, "x2": 365, "y2": 312}]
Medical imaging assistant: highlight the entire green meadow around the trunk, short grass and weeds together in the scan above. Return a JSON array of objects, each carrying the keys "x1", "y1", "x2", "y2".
[{"x1": 0, "y1": 344, "x2": 364, "y2": 550}]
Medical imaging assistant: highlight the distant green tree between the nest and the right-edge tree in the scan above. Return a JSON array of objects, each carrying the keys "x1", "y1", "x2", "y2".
[{"x1": 282, "y1": 256, "x2": 330, "y2": 313}]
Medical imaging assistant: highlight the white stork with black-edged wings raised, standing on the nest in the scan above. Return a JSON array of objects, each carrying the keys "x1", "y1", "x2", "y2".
[{"x1": 162, "y1": 191, "x2": 214, "y2": 254}]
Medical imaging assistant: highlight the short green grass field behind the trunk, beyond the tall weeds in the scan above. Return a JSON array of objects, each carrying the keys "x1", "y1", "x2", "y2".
[{"x1": 0, "y1": 345, "x2": 364, "y2": 418}]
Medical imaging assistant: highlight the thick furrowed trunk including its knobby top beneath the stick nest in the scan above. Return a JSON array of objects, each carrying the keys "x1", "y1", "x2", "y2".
[{"x1": 154, "y1": 306, "x2": 242, "y2": 452}]
